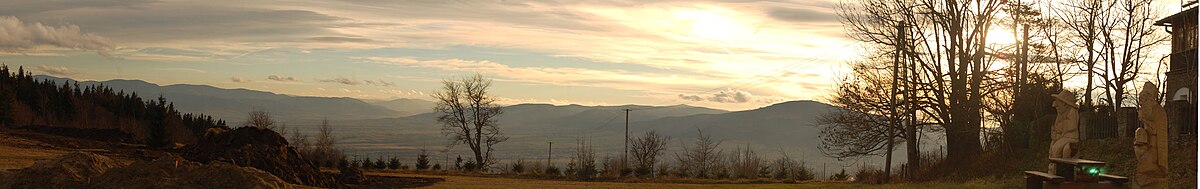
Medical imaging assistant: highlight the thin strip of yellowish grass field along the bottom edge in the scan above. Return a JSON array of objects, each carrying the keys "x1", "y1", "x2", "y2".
[{"x1": 368, "y1": 172, "x2": 1021, "y2": 189}]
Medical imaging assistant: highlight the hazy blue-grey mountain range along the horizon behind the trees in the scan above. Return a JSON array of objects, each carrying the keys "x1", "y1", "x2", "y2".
[{"x1": 32, "y1": 77, "x2": 904, "y2": 170}]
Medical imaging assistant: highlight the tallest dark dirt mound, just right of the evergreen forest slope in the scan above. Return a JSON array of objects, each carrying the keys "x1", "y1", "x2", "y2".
[{"x1": 177, "y1": 127, "x2": 336, "y2": 187}]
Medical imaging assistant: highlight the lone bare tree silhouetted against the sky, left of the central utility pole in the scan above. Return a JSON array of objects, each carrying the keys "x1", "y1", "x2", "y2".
[{"x1": 433, "y1": 74, "x2": 509, "y2": 169}]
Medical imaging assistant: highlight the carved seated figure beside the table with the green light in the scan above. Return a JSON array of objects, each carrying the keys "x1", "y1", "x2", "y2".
[{"x1": 1049, "y1": 90, "x2": 1079, "y2": 173}]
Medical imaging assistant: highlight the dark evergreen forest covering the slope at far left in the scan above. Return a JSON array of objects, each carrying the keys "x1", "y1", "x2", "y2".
[{"x1": 0, "y1": 66, "x2": 228, "y2": 146}]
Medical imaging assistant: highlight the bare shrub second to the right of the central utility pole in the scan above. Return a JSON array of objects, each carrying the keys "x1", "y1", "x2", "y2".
[{"x1": 676, "y1": 129, "x2": 724, "y2": 178}]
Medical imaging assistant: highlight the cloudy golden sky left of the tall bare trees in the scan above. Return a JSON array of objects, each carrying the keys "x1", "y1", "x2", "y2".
[{"x1": 0, "y1": 0, "x2": 883, "y2": 110}]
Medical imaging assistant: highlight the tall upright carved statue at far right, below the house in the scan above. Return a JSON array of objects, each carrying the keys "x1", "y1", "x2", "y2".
[{"x1": 1134, "y1": 83, "x2": 1168, "y2": 189}]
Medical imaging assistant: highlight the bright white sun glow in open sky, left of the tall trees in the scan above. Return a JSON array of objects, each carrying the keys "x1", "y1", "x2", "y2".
[{"x1": 676, "y1": 10, "x2": 751, "y2": 41}]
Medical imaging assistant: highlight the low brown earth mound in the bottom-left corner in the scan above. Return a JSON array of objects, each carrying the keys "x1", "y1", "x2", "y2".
[{"x1": 0, "y1": 152, "x2": 120, "y2": 188}]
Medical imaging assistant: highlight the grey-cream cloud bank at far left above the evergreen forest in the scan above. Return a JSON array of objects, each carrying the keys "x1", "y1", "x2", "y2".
[{"x1": 0, "y1": 17, "x2": 114, "y2": 56}]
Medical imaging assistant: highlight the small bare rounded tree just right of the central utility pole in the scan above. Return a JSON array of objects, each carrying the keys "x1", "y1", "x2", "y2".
[{"x1": 629, "y1": 132, "x2": 671, "y2": 176}]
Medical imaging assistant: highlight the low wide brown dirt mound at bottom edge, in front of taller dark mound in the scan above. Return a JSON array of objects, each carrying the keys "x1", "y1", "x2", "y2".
[{"x1": 91, "y1": 157, "x2": 290, "y2": 189}]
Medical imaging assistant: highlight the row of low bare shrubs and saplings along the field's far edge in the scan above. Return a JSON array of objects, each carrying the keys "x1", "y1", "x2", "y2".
[{"x1": 502, "y1": 132, "x2": 814, "y2": 182}]
